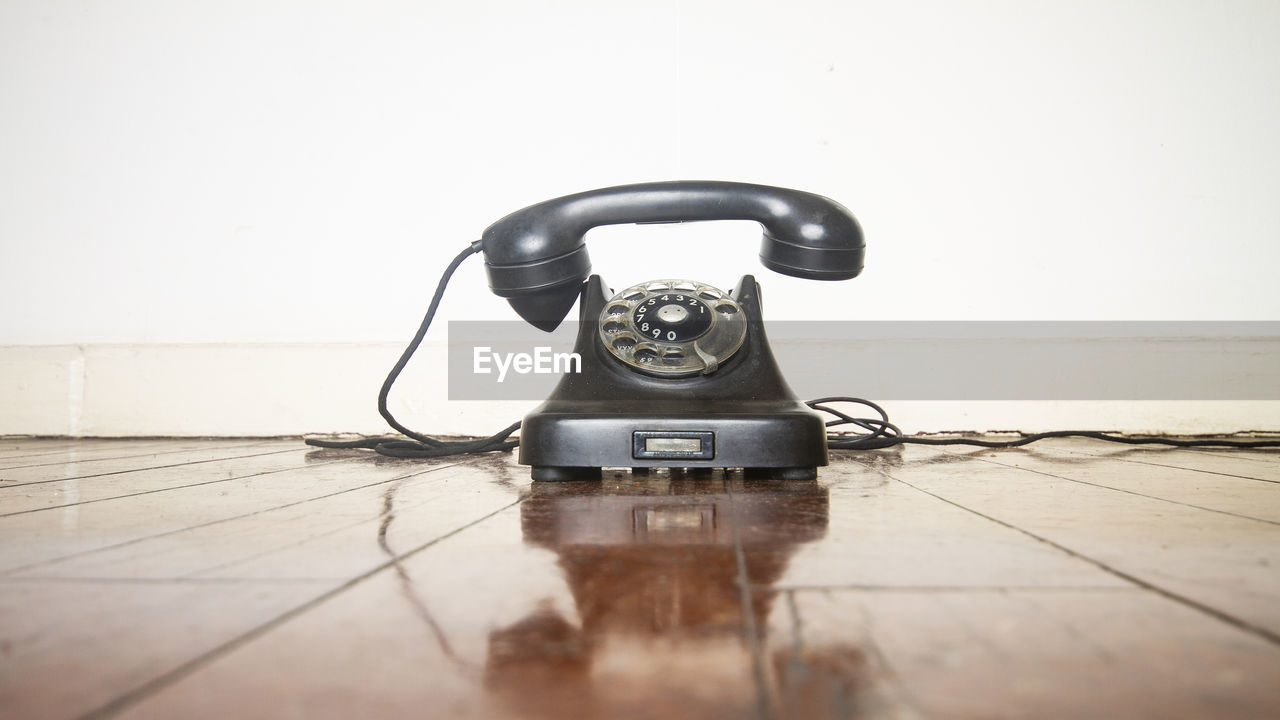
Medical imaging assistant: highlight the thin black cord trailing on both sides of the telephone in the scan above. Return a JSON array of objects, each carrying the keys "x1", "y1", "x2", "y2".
[{"x1": 306, "y1": 241, "x2": 1280, "y2": 457}]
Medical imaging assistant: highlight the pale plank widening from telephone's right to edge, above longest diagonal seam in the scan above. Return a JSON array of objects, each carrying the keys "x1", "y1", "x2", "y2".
[{"x1": 844, "y1": 448, "x2": 1280, "y2": 638}]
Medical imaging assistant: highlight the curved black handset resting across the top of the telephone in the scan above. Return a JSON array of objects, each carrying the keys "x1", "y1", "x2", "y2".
[{"x1": 481, "y1": 181, "x2": 865, "y2": 332}]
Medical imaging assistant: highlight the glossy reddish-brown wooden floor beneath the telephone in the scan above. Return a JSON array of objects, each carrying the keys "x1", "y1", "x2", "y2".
[{"x1": 0, "y1": 439, "x2": 1280, "y2": 719}]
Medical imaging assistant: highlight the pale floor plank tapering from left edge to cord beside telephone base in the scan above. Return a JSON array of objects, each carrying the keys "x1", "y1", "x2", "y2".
[{"x1": 0, "y1": 451, "x2": 465, "y2": 573}]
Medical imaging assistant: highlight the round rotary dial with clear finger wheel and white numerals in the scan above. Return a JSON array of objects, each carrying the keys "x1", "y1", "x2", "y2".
[{"x1": 600, "y1": 281, "x2": 746, "y2": 378}]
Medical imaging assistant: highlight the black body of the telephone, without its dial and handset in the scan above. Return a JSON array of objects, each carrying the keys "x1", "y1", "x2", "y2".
[{"x1": 520, "y1": 275, "x2": 827, "y2": 480}]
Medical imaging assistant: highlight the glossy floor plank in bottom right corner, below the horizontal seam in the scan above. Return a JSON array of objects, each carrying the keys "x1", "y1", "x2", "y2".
[{"x1": 767, "y1": 588, "x2": 1280, "y2": 720}]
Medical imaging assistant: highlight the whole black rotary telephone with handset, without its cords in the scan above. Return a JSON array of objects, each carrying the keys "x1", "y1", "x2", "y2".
[{"x1": 477, "y1": 182, "x2": 865, "y2": 480}]
